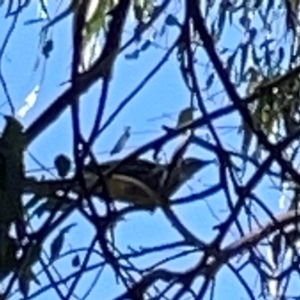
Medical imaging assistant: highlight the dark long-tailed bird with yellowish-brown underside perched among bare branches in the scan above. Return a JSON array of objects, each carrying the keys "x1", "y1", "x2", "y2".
[{"x1": 26, "y1": 157, "x2": 212, "y2": 211}]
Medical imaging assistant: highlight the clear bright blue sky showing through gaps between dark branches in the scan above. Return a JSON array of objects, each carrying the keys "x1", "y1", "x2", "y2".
[{"x1": 0, "y1": 0, "x2": 290, "y2": 300}]
